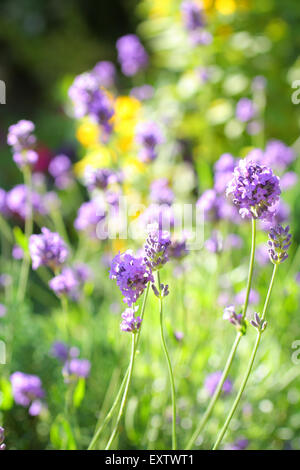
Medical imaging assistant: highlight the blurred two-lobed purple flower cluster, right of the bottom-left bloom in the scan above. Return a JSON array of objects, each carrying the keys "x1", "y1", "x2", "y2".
[{"x1": 51, "y1": 341, "x2": 91, "y2": 383}]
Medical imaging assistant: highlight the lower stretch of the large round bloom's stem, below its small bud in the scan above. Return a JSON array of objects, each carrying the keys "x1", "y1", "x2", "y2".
[{"x1": 186, "y1": 333, "x2": 242, "y2": 450}]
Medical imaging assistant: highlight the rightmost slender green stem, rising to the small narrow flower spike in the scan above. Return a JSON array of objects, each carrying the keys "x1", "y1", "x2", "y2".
[{"x1": 213, "y1": 264, "x2": 278, "y2": 450}]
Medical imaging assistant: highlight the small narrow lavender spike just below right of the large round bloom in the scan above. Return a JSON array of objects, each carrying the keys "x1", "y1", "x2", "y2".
[{"x1": 268, "y1": 225, "x2": 292, "y2": 264}]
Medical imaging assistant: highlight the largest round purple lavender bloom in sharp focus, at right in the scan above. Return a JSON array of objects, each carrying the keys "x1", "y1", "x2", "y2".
[{"x1": 226, "y1": 159, "x2": 281, "y2": 219}]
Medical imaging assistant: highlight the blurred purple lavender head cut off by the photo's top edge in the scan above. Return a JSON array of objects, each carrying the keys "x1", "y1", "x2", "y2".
[{"x1": 181, "y1": 0, "x2": 212, "y2": 45}]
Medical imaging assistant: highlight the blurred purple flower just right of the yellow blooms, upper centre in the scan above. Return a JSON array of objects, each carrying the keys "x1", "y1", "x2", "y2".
[{"x1": 135, "y1": 121, "x2": 163, "y2": 163}]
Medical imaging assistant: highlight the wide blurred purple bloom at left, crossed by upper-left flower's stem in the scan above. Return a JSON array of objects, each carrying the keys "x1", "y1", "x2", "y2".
[{"x1": 6, "y1": 184, "x2": 47, "y2": 219}]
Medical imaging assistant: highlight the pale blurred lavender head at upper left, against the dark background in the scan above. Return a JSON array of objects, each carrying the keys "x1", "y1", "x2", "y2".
[{"x1": 7, "y1": 119, "x2": 38, "y2": 169}]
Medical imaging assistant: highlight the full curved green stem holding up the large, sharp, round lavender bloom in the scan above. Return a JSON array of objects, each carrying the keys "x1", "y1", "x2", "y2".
[{"x1": 186, "y1": 219, "x2": 256, "y2": 450}]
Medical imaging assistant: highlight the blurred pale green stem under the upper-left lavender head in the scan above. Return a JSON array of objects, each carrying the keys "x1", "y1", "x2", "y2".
[{"x1": 17, "y1": 167, "x2": 33, "y2": 302}]
